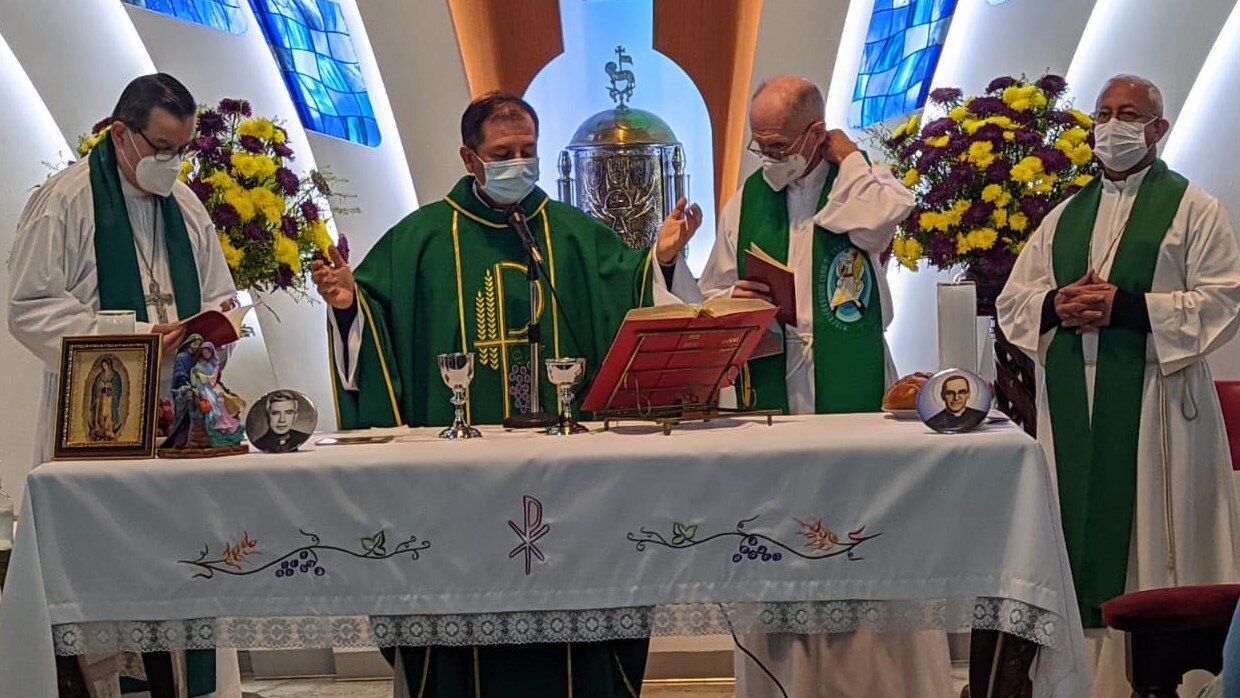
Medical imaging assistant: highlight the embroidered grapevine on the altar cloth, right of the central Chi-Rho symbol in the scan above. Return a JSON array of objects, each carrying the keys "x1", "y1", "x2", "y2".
[{"x1": 625, "y1": 516, "x2": 882, "y2": 563}]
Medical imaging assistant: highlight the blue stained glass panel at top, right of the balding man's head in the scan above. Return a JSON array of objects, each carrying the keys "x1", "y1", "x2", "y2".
[{"x1": 848, "y1": 0, "x2": 956, "y2": 129}]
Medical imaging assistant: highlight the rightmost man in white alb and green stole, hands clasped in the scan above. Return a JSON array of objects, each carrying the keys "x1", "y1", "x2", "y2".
[{"x1": 997, "y1": 76, "x2": 1240, "y2": 697}]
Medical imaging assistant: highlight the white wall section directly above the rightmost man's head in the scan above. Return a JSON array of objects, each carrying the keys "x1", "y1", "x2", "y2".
[{"x1": 1066, "y1": 0, "x2": 1235, "y2": 122}]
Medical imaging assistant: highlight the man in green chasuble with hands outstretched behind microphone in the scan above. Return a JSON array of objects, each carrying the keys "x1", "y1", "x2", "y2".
[{"x1": 312, "y1": 93, "x2": 702, "y2": 698}]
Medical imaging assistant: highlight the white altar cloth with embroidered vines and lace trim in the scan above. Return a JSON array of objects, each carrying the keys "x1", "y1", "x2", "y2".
[{"x1": 0, "y1": 414, "x2": 1089, "y2": 698}]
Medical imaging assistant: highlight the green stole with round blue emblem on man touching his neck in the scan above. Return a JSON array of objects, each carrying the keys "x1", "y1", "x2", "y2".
[{"x1": 737, "y1": 164, "x2": 887, "y2": 414}]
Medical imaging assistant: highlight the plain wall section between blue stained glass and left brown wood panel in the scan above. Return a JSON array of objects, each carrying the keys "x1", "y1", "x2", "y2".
[{"x1": 357, "y1": 0, "x2": 470, "y2": 207}]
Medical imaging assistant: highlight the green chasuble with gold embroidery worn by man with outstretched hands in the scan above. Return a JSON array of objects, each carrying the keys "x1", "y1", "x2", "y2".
[{"x1": 332, "y1": 177, "x2": 652, "y2": 698}]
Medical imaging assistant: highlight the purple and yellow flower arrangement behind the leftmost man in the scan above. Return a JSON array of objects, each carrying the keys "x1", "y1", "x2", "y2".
[{"x1": 77, "y1": 99, "x2": 348, "y2": 299}]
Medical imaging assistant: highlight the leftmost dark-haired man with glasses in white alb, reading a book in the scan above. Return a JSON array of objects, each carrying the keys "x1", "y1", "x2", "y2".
[{"x1": 9, "y1": 73, "x2": 239, "y2": 696}]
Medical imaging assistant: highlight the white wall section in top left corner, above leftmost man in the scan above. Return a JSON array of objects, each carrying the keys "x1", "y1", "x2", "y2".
[{"x1": 0, "y1": 0, "x2": 155, "y2": 146}]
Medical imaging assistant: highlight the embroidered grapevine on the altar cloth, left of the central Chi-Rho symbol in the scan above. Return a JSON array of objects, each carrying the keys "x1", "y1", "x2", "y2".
[{"x1": 176, "y1": 529, "x2": 430, "y2": 579}]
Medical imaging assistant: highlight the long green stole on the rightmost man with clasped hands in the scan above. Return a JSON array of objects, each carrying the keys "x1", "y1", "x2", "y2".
[{"x1": 1045, "y1": 160, "x2": 1188, "y2": 627}]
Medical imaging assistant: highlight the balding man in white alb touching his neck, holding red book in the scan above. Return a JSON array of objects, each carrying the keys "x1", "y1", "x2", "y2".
[{"x1": 699, "y1": 76, "x2": 952, "y2": 698}]
